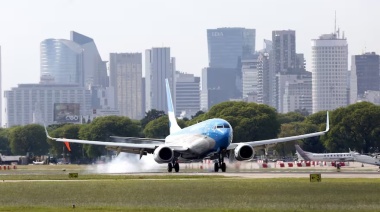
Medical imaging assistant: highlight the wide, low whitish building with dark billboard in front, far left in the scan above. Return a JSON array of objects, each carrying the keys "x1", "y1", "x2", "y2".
[{"x1": 5, "y1": 83, "x2": 92, "y2": 127}]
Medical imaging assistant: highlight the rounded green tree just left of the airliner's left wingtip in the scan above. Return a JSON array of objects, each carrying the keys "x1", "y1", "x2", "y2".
[{"x1": 9, "y1": 124, "x2": 49, "y2": 155}]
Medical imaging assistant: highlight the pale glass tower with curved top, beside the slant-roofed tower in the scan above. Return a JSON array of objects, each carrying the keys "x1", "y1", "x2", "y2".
[{"x1": 40, "y1": 39, "x2": 83, "y2": 85}]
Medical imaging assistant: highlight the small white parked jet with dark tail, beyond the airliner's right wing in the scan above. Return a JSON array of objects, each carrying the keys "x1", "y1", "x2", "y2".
[{"x1": 295, "y1": 144, "x2": 354, "y2": 167}]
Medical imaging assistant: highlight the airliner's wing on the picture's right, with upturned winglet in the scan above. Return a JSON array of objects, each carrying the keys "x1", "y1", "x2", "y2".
[{"x1": 227, "y1": 112, "x2": 330, "y2": 150}]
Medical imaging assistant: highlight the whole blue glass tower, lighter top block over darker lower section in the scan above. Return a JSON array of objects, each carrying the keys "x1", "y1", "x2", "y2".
[{"x1": 201, "y1": 27, "x2": 256, "y2": 110}]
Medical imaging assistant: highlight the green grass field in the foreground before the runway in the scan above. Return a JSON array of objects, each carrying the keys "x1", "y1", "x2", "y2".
[{"x1": 0, "y1": 171, "x2": 380, "y2": 211}]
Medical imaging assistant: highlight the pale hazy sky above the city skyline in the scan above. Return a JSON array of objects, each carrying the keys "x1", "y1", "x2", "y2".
[{"x1": 0, "y1": 0, "x2": 380, "y2": 91}]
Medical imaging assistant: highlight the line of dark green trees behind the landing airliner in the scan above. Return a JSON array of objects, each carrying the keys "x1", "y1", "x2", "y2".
[{"x1": 0, "y1": 102, "x2": 380, "y2": 161}]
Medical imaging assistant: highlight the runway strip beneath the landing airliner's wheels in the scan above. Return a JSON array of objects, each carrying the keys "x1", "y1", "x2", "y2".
[{"x1": 0, "y1": 162, "x2": 380, "y2": 180}]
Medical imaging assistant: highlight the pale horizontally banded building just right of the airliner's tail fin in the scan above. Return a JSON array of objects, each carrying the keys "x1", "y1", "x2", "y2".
[{"x1": 175, "y1": 71, "x2": 201, "y2": 118}]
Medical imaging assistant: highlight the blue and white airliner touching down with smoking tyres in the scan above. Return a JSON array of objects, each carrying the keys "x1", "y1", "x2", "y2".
[{"x1": 45, "y1": 79, "x2": 329, "y2": 172}]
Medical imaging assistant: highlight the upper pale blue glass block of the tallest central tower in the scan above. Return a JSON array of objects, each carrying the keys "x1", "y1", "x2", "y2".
[{"x1": 207, "y1": 28, "x2": 256, "y2": 68}]
